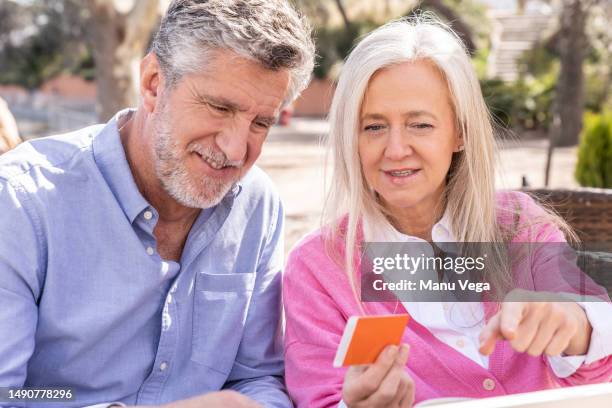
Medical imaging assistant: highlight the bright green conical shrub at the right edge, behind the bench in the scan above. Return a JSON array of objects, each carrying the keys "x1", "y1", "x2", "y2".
[{"x1": 574, "y1": 111, "x2": 612, "y2": 188}]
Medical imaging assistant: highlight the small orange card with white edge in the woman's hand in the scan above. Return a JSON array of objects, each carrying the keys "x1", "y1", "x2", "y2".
[{"x1": 334, "y1": 314, "x2": 410, "y2": 367}]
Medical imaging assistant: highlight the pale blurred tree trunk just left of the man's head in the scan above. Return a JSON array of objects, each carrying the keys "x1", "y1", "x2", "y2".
[{"x1": 85, "y1": 0, "x2": 160, "y2": 121}]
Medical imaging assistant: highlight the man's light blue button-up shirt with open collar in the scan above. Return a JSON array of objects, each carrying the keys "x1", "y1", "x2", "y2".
[{"x1": 0, "y1": 112, "x2": 291, "y2": 407}]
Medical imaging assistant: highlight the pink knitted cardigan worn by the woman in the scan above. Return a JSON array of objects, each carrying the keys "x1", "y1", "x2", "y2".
[{"x1": 283, "y1": 192, "x2": 612, "y2": 408}]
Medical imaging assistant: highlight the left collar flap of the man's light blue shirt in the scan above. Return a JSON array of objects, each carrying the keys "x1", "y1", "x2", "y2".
[{"x1": 93, "y1": 109, "x2": 149, "y2": 223}]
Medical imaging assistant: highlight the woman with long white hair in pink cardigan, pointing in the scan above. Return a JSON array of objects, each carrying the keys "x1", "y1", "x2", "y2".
[{"x1": 284, "y1": 18, "x2": 612, "y2": 407}]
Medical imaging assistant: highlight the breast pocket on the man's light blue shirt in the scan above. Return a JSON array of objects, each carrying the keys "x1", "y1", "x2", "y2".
[{"x1": 191, "y1": 272, "x2": 255, "y2": 374}]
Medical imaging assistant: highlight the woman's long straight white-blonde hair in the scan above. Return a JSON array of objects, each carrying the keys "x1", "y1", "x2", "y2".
[{"x1": 323, "y1": 15, "x2": 556, "y2": 310}]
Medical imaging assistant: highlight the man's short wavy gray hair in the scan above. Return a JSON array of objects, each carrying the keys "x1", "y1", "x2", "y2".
[{"x1": 151, "y1": 0, "x2": 315, "y2": 103}]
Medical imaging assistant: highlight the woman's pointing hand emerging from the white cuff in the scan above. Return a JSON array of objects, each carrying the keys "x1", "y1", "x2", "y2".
[{"x1": 480, "y1": 289, "x2": 593, "y2": 357}]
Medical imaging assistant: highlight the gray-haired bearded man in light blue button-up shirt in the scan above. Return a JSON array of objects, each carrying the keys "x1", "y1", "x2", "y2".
[{"x1": 0, "y1": 0, "x2": 314, "y2": 407}]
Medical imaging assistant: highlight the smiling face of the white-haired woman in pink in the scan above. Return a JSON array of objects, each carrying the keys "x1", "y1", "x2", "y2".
[{"x1": 359, "y1": 61, "x2": 462, "y2": 212}]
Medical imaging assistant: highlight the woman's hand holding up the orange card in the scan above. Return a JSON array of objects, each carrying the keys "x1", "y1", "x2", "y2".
[{"x1": 342, "y1": 344, "x2": 414, "y2": 408}]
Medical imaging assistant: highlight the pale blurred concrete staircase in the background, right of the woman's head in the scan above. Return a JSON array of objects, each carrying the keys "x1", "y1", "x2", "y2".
[{"x1": 487, "y1": 11, "x2": 555, "y2": 81}]
